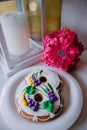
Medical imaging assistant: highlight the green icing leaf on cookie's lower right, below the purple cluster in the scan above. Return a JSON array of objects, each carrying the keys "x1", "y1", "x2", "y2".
[{"x1": 41, "y1": 100, "x2": 53, "y2": 112}]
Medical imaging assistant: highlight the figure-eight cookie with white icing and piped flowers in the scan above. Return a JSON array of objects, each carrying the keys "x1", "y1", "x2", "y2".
[{"x1": 16, "y1": 70, "x2": 63, "y2": 122}]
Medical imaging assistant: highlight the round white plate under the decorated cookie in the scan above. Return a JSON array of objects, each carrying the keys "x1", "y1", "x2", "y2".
[{"x1": 0, "y1": 66, "x2": 83, "y2": 130}]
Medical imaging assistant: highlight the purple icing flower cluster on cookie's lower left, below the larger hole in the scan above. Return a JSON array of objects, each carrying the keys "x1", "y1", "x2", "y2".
[{"x1": 27, "y1": 95, "x2": 39, "y2": 111}]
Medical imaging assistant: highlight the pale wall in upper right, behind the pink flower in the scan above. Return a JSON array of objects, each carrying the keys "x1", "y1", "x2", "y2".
[{"x1": 61, "y1": 0, "x2": 87, "y2": 48}]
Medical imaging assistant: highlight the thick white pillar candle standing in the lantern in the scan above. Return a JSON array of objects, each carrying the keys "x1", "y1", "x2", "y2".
[{"x1": 1, "y1": 12, "x2": 30, "y2": 56}]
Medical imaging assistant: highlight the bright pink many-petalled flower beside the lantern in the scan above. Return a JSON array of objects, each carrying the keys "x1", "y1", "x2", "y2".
[{"x1": 42, "y1": 28, "x2": 84, "y2": 71}]
